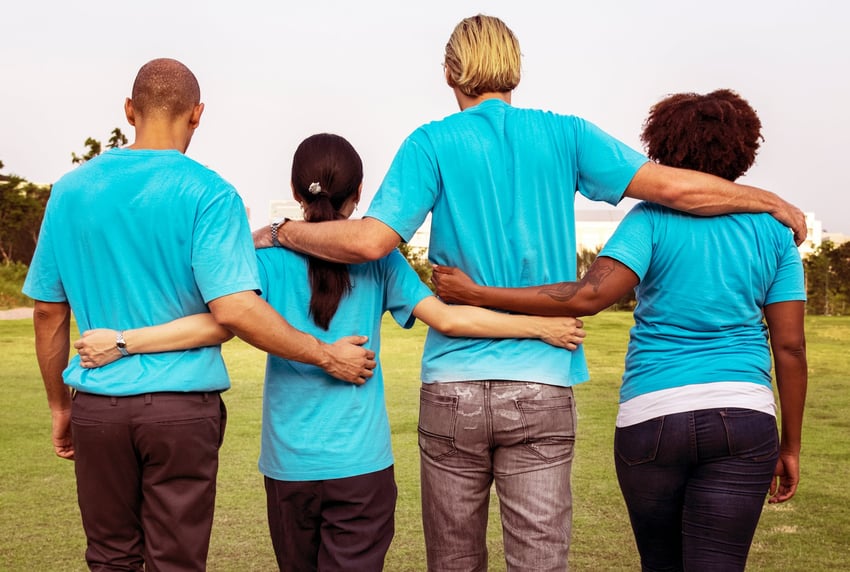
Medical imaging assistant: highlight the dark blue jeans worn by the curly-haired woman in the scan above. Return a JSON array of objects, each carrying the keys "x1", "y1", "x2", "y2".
[{"x1": 614, "y1": 408, "x2": 779, "y2": 572}]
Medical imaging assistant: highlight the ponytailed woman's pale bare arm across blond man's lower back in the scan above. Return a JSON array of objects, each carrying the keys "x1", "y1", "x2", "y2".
[{"x1": 413, "y1": 296, "x2": 585, "y2": 350}]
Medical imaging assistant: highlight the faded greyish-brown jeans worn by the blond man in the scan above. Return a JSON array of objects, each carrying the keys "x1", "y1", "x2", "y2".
[{"x1": 419, "y1": 381, "x2": 575, "y2": 572}]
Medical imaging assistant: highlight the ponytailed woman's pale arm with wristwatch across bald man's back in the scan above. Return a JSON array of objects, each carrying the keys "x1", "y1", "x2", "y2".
[{"x1": 74, "y1": 314, "x2": 233, "y2": 368}]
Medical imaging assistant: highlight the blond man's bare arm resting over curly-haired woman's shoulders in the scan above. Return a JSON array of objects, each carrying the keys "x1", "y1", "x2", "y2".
[{"x1": 625, "y1": 162, "x2": 808, "y2": 245}]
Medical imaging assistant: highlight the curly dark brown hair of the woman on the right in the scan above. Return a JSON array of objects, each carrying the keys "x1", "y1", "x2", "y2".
[{"x1": 640, "y1": 89, "x2": 764, "y2": 181}]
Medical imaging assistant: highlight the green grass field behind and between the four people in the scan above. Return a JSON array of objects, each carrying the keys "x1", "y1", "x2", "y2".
[{"x1": 0, "y1": 312, "x2": 850, "y2": 572}]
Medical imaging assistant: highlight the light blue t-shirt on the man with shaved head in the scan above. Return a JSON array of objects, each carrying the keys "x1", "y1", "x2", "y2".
[{"x1": 24, "y1": 149, "x2": 259, "y2": 396}]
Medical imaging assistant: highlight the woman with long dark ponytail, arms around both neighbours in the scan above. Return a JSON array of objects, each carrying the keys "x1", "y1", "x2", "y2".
[{"x1": 75, "y1": 133, "x2": 584, "y2": 571}]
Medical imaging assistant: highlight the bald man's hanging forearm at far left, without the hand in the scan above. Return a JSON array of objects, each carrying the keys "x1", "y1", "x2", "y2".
[{"x1": 33, "y1": 301, "x2": 71, "y2": 413}]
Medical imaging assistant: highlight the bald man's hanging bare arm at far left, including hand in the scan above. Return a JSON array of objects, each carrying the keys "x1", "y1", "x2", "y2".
[{"x1": 33, "y1": 301, "x2": 74, "y2": 459}]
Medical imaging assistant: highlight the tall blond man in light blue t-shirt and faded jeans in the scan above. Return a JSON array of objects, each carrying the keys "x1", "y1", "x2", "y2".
[{"x1": 254, "y1": 15, "x2": 805, "y2": 572}]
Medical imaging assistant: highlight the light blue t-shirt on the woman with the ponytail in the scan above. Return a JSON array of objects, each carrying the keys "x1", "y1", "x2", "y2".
[{"x1": 257, "y1": 248, "x2": 432, "y2": 481}]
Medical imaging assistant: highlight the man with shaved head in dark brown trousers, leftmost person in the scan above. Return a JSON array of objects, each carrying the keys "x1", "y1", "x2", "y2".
[{"x1": 24, "y1": 59, "x2": 375, "y2": 570}]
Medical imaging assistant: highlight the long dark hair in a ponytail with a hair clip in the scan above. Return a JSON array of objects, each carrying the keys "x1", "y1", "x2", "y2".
[{"x1": 292, "y1": 133, "x2": 363, "y2": 330}]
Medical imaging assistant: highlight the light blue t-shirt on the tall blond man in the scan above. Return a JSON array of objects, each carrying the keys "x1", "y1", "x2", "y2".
[{"x1": 366, "y1": 99, "x2": 646, "y2": 386}]
